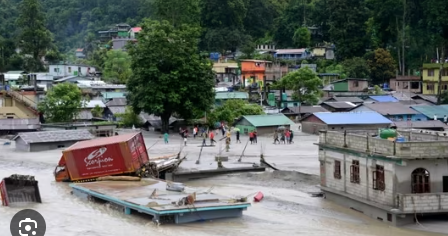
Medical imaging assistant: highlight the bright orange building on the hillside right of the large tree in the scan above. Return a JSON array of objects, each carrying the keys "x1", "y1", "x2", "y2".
[{"x1": 241, "y1": 60, "x2": 272, "y2": 87}]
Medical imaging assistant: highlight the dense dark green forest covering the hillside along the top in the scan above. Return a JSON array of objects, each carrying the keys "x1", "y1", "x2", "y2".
[{"x1": 0, "y1": 0, "x2": 448, "y2": 78}]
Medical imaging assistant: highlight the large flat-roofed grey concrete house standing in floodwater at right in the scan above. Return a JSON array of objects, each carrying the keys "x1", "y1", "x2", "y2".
[{"x1": 318, "y1": 131, "x2": 448, "y2": 226}]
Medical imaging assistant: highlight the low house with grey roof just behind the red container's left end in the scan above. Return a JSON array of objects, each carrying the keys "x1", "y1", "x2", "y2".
[{"x1": 13, "y1": 129, "x2": 95, "y2": 152}]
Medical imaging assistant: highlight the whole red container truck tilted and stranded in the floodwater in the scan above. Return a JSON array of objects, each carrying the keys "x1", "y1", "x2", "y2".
[{"x1": 54, "y1": 132, "x2": 152, "y2": 182}]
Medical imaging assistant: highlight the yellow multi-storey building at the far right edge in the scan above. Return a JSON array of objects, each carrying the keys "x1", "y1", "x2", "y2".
[{"x1": 422, "y1": 63, "x2": 448, "y2": 94}]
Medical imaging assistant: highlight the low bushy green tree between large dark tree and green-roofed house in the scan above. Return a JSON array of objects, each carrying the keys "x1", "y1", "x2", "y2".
[{"x1": 207, "y1": 99, "x2": 264, "y2": 127}]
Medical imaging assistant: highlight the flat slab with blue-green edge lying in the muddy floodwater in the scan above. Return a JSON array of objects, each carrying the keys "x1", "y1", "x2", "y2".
[{"x1": 70, "y1": 179, "x2": 251, "y2": 224}]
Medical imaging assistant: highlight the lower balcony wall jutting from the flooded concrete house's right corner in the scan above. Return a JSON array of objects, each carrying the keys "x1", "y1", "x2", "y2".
[{"x1": 396, "y1": 193, "x2": 448, "y2": 214}]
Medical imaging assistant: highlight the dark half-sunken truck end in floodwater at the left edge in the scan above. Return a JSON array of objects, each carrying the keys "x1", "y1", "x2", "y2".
[{"x1": 0, "y1": 175, "x2": 42, "y2": 206}]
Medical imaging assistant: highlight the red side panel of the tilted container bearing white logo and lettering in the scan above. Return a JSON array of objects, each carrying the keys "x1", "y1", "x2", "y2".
[{"x1": 71, "y1": 143, "x2": 127, "y2": 179}]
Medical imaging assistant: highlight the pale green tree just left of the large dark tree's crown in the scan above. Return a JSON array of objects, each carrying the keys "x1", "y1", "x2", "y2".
[{"x1": 104, "y1": 50, "x2": 132, "y2": 83}]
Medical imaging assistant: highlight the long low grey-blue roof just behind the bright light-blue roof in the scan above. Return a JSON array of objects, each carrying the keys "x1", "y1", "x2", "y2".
[{"x1": 351, "y1": 102, "x2": 427, "y2": 121}]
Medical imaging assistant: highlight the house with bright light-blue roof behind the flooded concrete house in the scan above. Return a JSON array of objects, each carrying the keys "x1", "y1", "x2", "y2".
[{"x1": 302, "y1": 112, "x2": 392, "y2": 134}]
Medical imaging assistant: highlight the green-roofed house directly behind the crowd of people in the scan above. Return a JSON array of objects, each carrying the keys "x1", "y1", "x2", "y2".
[{"x1": 235, "y1": 114, "x2": 294, "y2": 135}]
